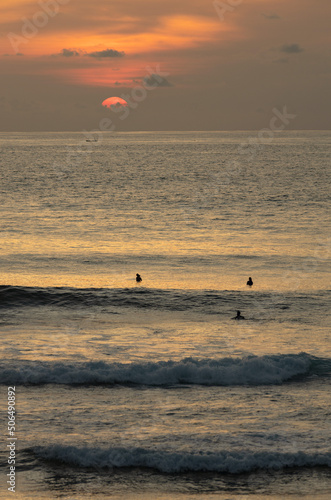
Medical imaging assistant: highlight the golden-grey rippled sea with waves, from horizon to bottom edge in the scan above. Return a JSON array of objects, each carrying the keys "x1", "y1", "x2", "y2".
[{"x1": 0, "y1": 132, "x2": 331, "y2": 500}]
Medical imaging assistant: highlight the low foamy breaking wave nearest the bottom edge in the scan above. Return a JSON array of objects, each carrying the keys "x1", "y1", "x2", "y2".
[{"x1": 30, "y1": 445, "x2": 331, "y2": 474}]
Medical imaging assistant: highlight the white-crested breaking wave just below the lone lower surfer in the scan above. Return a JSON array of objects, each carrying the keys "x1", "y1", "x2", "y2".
[{"x1": 0, "y1": 353, "x2": 331, "y2": 387}]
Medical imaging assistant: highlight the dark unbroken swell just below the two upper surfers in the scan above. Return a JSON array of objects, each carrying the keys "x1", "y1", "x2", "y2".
[{"x1": 0, "y1": 286, "x2": 327, "y2": 314}]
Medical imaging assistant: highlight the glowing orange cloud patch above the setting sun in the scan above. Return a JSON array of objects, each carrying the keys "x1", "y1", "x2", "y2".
[{"x1": 1, "y1": 0, "x2": 235, "y2": 86}]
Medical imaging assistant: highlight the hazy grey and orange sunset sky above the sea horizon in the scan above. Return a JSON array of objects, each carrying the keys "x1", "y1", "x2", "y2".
[{"x1": 0, "y1": 0, "x2": 331, "y2": 132}]
